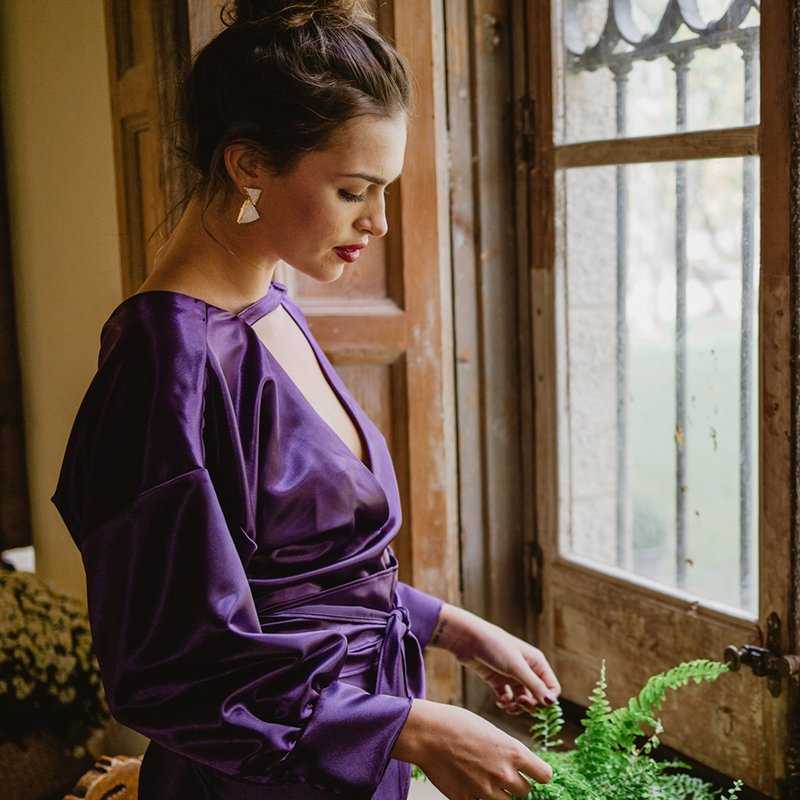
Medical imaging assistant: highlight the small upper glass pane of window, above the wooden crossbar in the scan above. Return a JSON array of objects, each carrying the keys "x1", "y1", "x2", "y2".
[{"x1": 553, "y1": 0, "x2": 760, "y2": 144}]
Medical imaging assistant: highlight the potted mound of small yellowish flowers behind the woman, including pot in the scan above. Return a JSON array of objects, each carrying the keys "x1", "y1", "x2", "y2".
[{"x1": 0, "y1": 562, "x2": 110, "y2": 798}]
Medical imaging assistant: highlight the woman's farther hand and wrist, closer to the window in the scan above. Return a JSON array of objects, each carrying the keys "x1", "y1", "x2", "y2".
[{"x1": 430, "y1": 603, "x2": 561, "y2": 714}]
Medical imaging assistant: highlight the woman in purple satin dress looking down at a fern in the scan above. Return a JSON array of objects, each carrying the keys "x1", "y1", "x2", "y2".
[{"x1": 52, "y1": 0, "x2": 560, "y2": 800}]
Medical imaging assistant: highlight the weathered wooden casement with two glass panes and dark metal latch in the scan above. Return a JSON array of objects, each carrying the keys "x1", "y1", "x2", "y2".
[{"x1": 526, "y1": 0, "x2": 798, "y2": 797}]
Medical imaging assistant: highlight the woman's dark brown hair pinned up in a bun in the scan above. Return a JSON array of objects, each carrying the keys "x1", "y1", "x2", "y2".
[{"x1": 155, "y1": 0, "x2": 410, "y2": 244}]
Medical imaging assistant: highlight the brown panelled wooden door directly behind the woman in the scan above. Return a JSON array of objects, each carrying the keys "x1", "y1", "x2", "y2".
[{"x1": 107, "y1": 0, "x2": 461, "y2": 701}]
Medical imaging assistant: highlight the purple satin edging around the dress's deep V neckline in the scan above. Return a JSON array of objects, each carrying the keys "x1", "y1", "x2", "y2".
[{"x1": 242, "y1": 281, "x2": 382, "y2": 478}]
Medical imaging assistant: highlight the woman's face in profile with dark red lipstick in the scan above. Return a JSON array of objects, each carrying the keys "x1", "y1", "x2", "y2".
[{"x1": 231, "y1": 114, "x2": 406, "y2": 282}]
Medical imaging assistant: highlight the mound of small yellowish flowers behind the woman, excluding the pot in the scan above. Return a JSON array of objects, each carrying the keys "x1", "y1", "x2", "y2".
[{"x1": 0, "y1": 569, "x2": 110, "y2": 758}]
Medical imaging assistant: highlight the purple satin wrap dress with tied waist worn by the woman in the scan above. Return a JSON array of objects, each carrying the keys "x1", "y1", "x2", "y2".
[{"x1": 51, "y1": 282, "x2": 442, "y2": 800}]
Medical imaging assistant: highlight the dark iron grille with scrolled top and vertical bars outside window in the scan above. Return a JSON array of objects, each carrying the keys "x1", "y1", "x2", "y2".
[{"x1": 561, "y1": 0, "x2": 760, "y2": 609}]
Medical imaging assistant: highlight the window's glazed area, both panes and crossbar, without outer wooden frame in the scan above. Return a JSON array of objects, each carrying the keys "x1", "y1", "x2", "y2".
[{"x1": 554, "y1": 0, "x2": 759, "y2": 618}]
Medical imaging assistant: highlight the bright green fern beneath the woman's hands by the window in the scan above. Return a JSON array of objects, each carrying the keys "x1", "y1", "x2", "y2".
[{"x1": 412, "y1": 659, "x2": 742, "y2": 800}]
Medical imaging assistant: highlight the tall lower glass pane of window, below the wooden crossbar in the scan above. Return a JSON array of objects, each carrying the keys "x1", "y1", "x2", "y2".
[{"x1": 558, "y1": 158, "x2": 759, "y2": 614}]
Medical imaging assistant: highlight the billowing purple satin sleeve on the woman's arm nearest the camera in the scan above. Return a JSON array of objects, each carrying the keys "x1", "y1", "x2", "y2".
[{"x1": 52, "y1": 307, "x2": 412, "y2": 800}]
